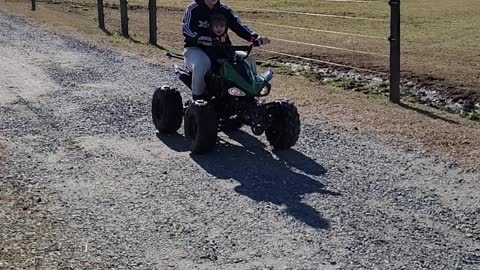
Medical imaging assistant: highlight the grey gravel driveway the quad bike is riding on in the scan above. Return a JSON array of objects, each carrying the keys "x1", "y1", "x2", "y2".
[{"x1": 0, "y1": 12, "x2": 480, "y2": 269}]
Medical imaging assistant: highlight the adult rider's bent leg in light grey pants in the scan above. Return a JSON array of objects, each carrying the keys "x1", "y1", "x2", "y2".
[{"x1": 183, "y1": 47, "x2": 212, "y2": 97}]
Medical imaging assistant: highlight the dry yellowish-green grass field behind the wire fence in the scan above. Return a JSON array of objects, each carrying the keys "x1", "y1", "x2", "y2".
[{"x1": 49, "y1": 0, "x2": 480, "y2": 91}]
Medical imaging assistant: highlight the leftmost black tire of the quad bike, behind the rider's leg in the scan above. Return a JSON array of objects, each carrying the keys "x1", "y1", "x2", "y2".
[{"x1": 152, "y1": 87, "x2": 183, "y2": 133}]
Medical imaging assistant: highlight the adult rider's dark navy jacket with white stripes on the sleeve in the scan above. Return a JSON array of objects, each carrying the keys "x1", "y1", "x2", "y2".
[{"x1": 183, "y1": 0, "x2": 258, "y2": 47}]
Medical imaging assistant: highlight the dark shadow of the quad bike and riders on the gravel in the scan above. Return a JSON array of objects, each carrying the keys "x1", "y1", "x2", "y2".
[{"x1": 191, "y1": 131, "x2": 341, "y2": 229}]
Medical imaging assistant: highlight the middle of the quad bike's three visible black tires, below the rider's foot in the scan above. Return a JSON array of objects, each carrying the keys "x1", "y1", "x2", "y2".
[{"x1": 184, "y1": 104, "x2": 218, "y2": 154}]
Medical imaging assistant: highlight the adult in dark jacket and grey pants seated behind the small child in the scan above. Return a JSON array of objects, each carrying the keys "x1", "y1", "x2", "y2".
[{"x1": 183, "y1": 0, "x2": 270, "y2": 100}]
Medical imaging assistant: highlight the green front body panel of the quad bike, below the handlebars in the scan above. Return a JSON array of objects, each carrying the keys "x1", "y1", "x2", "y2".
[{"x1": 220, "y1": 60, "x2": 265, "y2": 96}]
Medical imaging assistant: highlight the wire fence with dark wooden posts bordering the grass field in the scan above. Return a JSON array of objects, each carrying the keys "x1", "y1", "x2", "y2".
[{"x1": 27, "y1": 0, "x2": 400, "y2": 102}]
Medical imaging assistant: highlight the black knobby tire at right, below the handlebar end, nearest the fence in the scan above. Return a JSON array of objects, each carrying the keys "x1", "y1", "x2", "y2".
[{"x1": 265, "y1": 102, "x2": 300, "y2": 150}]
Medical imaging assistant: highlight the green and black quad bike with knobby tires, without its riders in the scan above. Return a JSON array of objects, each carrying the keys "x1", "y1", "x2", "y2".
[{"x1": 152, "y1": 44, "x2": 300, "y2": 154}]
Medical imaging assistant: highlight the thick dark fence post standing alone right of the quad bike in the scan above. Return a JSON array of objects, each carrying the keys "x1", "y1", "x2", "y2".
[{"x1": 388, "y1": 0, "x2": 400, "y2": 104}]
